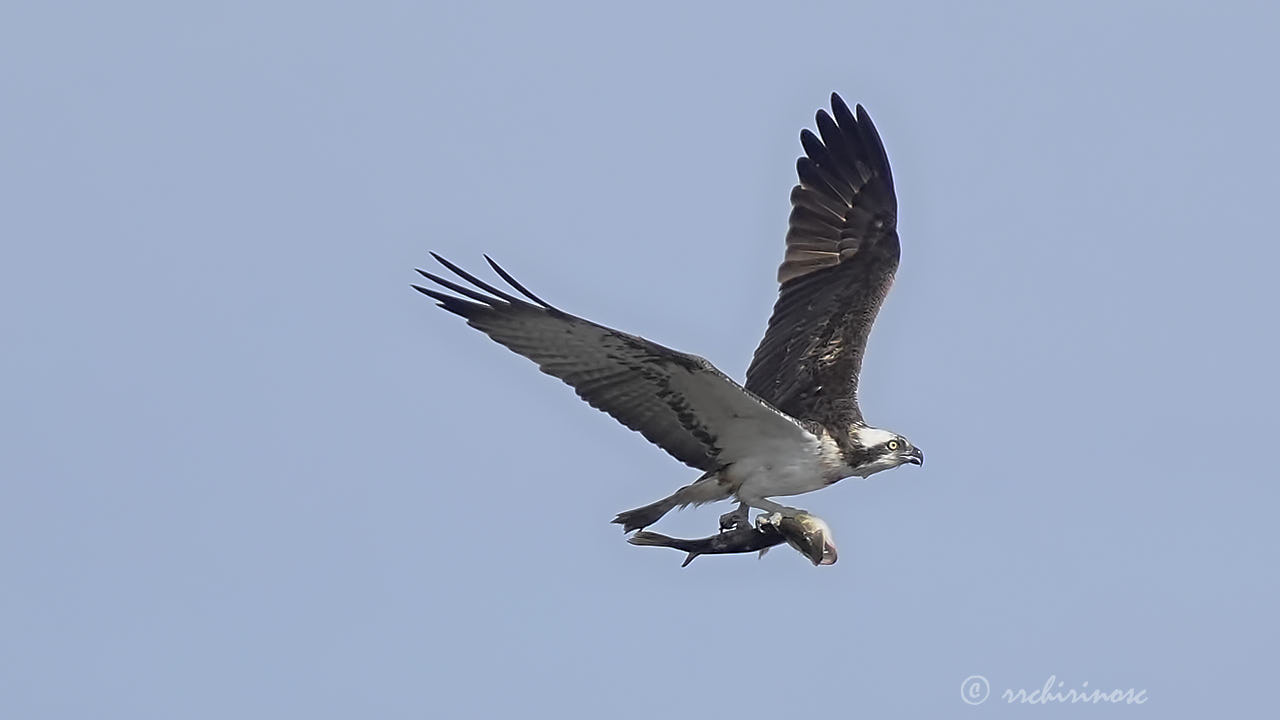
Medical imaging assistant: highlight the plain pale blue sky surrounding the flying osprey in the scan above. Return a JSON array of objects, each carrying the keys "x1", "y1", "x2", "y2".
[{"x1": 0, "y1": 3, "x2": 1280, "y2": 719}]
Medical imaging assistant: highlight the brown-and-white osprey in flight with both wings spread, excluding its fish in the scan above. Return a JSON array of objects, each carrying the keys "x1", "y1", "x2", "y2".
[{"x1": 413, "y1": 94, "x2": 924, "y2": 532}]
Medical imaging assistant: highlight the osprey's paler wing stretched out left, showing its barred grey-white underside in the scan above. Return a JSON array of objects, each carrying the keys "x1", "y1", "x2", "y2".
[{"x1": 413, "y1": 252, "x2": 817, "y2": 471}]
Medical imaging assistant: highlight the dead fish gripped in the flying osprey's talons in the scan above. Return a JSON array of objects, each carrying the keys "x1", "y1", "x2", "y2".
[{"x1": 627, "y1": 512, "x2": 837, "y2": 568}]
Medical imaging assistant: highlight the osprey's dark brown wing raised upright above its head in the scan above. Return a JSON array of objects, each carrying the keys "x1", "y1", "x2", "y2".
[{"x1": 746, "y1": 94, "x2": 899, "y2": 421}]
